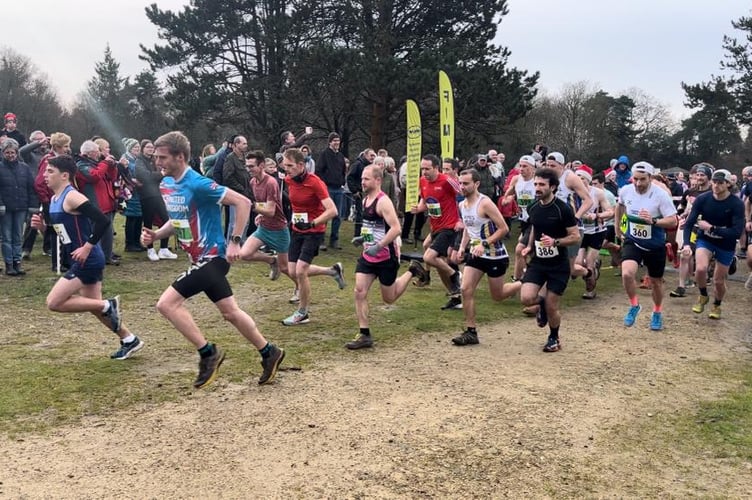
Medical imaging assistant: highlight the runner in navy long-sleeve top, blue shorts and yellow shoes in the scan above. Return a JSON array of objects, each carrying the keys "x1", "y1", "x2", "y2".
[{"x1": 682, "y1": 169, "x2": 744, "y2": 319}]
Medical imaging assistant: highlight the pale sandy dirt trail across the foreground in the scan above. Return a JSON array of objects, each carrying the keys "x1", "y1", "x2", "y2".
[{"x1": 0, "y1": 283, "x2": 752, "y2": 498}]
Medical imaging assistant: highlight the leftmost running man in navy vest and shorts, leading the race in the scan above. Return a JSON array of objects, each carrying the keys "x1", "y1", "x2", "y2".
[{"x1": 31, "y1": 155, "x2": 144, "y2": 360}]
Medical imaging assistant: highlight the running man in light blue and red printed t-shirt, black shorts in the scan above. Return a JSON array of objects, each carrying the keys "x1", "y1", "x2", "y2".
[{"x1": 141, "y1": 132, "x2": 285, "y2": 389}]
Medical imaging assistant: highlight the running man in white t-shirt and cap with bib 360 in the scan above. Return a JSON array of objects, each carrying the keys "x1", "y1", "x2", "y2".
[{"x1": 614, "y1": 161, "x2": 676, "y2": 331}]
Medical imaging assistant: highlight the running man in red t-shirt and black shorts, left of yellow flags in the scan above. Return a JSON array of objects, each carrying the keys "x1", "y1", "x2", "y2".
[{"x1": 282, "y1": 148, "x2": 345, "y2": 326}]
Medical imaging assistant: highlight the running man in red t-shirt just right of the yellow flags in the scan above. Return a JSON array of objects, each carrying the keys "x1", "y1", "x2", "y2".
[{"x1": 411, "y1": 154, "x2": 462, "y2": 309}]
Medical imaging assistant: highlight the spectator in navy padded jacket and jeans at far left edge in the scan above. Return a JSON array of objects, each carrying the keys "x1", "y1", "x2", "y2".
[{"x1": 0, "y1": 138, "x2": 39, "y2": 276}]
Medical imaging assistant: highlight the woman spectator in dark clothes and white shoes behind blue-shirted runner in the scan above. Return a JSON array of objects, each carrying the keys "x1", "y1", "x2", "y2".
[{"x1": 136, "y1": 139, "x2": 178, "y2": 262}]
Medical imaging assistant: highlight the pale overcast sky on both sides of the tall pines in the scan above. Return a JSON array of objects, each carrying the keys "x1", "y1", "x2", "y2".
[{"x1": 0, "y1": 0, "x2": 752, "y2": 122}]
